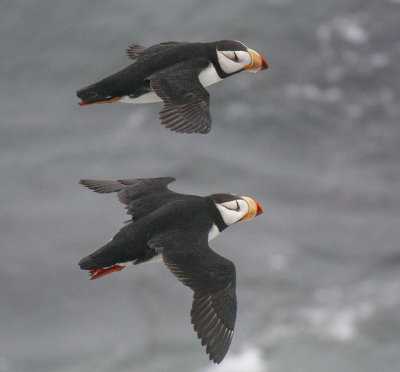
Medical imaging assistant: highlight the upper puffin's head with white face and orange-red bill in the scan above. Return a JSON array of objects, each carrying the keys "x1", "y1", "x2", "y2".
[{"x1": 216, "y1": 40, "x2": 269, "y2": 75}]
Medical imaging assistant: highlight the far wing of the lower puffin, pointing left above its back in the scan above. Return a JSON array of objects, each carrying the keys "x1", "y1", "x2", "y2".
[{"x1": 79, "y1": 177, "x2": 177, "y2": 220}]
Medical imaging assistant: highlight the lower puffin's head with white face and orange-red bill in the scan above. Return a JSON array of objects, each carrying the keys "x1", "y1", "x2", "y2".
[{"x1": 208, "y1": 194, "x2": 263, "y2": 226}]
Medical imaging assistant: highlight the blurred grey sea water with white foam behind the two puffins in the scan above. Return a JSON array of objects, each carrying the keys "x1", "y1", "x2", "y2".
[{"x1": 0, "y1": 0, "x2": 400, "y2": 372}]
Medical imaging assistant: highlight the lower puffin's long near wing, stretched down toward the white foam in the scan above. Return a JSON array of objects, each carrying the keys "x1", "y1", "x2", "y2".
[{"x1": 149, "y1": 229, "x2": 237, "y2": 363}]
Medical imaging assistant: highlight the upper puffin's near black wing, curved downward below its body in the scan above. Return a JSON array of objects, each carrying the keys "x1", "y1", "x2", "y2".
[{"x1": 148, "y1": 58, "x2": 211, "y2": 133}]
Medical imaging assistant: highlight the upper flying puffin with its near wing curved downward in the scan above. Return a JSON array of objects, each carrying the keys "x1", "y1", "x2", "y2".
[{"x1": 76, "y1": 40, "x2": 269, "y2": 133}]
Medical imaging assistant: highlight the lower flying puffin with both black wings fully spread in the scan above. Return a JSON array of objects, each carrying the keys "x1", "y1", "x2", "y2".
[{"x1": 79, "y1": 177, "x2": 263, "y2": 363}]
